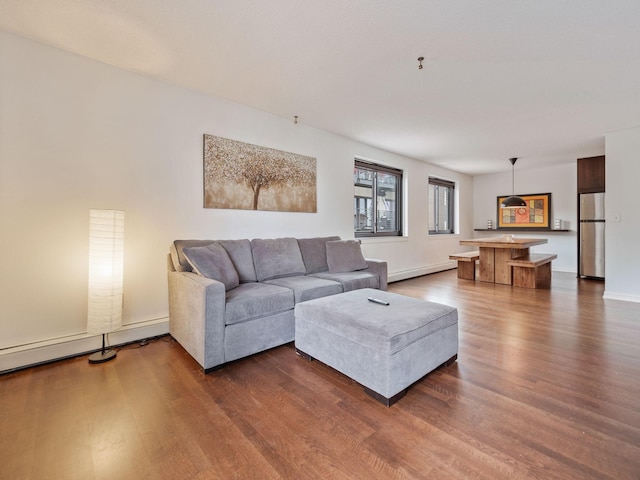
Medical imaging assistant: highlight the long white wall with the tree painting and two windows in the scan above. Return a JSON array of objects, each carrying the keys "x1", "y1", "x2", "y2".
[{"x1": 0, "y1": 32, "x2": 472, "y2": 371}]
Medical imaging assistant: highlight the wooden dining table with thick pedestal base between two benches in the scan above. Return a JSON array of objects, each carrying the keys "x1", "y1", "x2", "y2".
[{"x1": 460, "y1": 235, "x2": 547, "y2": 285}]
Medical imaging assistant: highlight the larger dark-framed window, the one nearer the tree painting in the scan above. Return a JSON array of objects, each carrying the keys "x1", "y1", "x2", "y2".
[{"x1": 353, "y1": 160, "x2": 402, "y2": 237}]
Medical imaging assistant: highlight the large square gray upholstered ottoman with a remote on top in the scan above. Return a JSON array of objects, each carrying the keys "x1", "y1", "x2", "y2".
[{"x1": 295, "y1": 288, "x2": 458, "y2": 406}]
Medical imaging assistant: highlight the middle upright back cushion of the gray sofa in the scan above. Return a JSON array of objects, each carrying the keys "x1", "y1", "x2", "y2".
[{"x1": 251, "y1": 238, "x2": 306, "y2": 282}]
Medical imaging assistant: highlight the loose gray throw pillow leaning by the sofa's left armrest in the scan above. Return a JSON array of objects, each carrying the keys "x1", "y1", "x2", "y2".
[{"x1": 183, "y1": 243, "x2": 240, "y2": 290}]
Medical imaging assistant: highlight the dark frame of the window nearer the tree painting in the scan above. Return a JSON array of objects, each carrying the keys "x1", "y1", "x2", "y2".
[{"x1": 352, "y1": 158, "x2": 403, "y2": 238}]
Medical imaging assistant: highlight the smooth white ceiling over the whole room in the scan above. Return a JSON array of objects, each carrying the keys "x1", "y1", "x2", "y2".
[{"x1": 0, "y1": 0, "x2": 640, "y2": 175}]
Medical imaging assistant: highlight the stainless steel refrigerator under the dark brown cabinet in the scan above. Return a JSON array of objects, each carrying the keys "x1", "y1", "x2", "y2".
[{"x1": 578, "y1": 193, "x2": 604, "y2": 278}]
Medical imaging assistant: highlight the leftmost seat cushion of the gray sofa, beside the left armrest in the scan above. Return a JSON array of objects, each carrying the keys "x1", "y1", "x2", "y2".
[{"x1": 224, "y1": 283, "x2": 295, "y2": 325}]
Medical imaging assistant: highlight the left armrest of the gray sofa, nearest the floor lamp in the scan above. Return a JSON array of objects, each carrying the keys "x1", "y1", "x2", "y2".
[{"x1": 168, "y1": 271, "x2": 226, "y2": 371}]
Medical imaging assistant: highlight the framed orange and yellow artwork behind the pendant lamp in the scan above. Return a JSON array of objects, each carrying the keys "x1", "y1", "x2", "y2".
[{"x1": 496, "y1": 193, "x2": 551, "y2": 230}]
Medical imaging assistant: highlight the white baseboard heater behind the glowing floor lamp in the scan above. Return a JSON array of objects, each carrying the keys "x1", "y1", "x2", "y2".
[{"x1": 0, "y1": 317, "x2": 169, "y2": 373}]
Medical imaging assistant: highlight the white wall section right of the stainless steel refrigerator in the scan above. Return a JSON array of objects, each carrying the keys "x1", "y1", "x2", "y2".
[{"x1": 604, "y1": 128, "x2": 640, "y2": 302}]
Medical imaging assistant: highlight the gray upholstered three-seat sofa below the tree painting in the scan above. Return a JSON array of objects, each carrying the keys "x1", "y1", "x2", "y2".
[{"x1": 168, "y1": 236, "x2": 387, "y2": 372}]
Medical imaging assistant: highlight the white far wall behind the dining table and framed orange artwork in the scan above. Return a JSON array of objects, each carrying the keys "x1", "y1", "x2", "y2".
[{"x1": 473, "y1": 159, "x2": 578, "y2": 273}]
